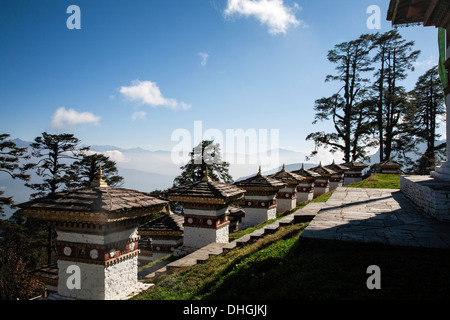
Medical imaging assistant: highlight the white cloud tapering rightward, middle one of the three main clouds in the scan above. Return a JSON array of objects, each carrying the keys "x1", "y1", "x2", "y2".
[{"x1": 120, "y1": 80, "x2": 191, "y2": 110}]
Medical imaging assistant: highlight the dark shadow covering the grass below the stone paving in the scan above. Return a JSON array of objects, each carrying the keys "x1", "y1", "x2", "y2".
[{"x1": 204, "y1": 232, "x2": 450, "y2": 300}]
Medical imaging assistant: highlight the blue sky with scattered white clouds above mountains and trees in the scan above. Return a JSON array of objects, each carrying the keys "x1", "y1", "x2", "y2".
[{"x1": 0, "y1": 0, "x2": 438, "y2": 153}]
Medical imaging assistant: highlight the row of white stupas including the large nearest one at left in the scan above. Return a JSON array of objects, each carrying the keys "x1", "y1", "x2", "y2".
[{"x1": 19, "y1": 160, "x2": 398, "y2": 300}]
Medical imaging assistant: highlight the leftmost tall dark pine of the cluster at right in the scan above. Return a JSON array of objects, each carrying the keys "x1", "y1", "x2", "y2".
[{"x1": 306, "y1": 35, "x2": 372, "y2": 162}]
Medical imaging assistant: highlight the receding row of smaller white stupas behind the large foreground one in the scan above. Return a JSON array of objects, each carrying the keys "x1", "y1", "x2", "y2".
[{"x1": 139, "y1": 162, "x2": 397, "y2": 264}]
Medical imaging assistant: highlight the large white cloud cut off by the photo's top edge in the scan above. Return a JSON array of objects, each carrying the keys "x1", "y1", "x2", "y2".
[{"x1": 225, "y1": 0, "x2": 305, "y2": 35}]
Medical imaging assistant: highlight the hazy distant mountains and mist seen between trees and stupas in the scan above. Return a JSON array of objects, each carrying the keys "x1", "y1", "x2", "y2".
[{"x1": 0, "y1": 139, "x2": 440, "y2": 220}]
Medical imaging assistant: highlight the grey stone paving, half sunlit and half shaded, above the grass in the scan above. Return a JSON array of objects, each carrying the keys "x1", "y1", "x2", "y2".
[{"x1": 301, "y1": 187, "x2": 450, "y2": 249}]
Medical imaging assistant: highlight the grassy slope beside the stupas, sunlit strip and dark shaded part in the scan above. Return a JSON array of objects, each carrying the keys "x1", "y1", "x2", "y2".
[{"x1": 135, "y1": 176, "x2": 450, "y2": 300}]
